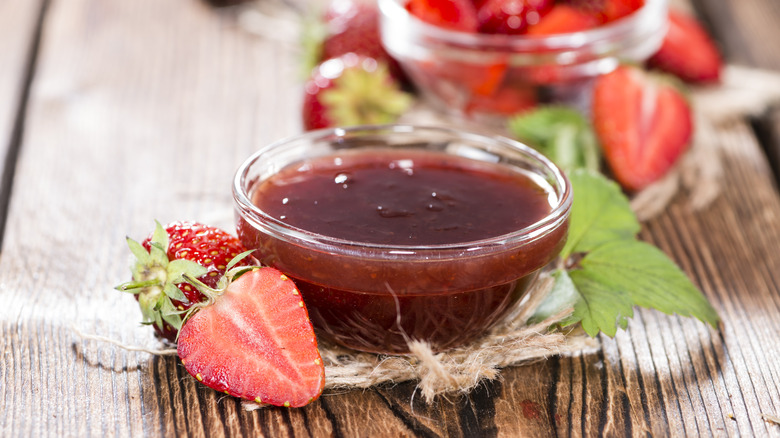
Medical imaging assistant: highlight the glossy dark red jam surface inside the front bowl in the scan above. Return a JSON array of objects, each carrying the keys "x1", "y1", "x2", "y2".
[{"x1": 253, "y1": 151, "x2": 551, "y2": 245}]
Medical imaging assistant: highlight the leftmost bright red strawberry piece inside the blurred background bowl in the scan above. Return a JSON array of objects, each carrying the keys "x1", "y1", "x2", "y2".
[{"x1": 406, "y1": 0, "x2": 479, "y2": 32}]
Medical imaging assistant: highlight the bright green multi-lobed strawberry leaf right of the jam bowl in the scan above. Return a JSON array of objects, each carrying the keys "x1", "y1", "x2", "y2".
[{"x1": 532, "y1": 170, "x2": 718, "y2": 336}]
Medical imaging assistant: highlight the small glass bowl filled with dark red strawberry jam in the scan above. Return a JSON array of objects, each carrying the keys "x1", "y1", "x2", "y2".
[{"x1": 235, "y1": 128, "x2": 570, "y2": 353}]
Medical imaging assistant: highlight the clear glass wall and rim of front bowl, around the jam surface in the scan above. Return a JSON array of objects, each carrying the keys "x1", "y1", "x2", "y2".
[{"x1": 233, "y1": 125, "x2": 572, "y2": 354}]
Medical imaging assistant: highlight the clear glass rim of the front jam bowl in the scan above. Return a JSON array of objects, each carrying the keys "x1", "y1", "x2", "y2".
[{"x1": 233, "y1": 124, "x2": 573, "y2": 253}]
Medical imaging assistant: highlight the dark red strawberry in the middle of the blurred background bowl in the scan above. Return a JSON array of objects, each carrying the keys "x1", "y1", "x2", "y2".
[{"x1": 477, "y1": 0, "x2": 553, "y2": 35}]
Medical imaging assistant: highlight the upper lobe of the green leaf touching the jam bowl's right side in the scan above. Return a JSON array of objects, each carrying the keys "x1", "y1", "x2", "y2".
[{"x1": 561, "y1": 170, "x2": 640, "y2": 259}]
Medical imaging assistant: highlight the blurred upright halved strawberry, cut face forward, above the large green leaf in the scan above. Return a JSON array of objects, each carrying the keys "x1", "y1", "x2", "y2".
[{"x1": 593, "y1": 66, "x2": 693, "y2": 191}]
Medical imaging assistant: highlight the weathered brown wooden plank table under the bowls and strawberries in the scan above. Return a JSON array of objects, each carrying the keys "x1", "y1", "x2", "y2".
[{"x1": 0, "y1": 0, "x2": 780, "y2": 437}]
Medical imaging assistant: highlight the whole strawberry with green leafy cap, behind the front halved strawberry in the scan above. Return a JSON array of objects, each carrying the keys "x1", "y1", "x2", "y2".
[{"x1": 117, "y1": 222, "x2": 246, "y2": 341}]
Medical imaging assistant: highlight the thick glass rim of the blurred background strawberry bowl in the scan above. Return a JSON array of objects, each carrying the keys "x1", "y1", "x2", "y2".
[{"x1": 378, "y1": 0, "x2": 668, "y2": 52}]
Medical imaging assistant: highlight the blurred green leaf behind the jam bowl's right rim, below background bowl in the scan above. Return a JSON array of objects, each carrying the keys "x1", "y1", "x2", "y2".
[{"x1": 508, "y1": 106, "x2": 601, "y2": 172}]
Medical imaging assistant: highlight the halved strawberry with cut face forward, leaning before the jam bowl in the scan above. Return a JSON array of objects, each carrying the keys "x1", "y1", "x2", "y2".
[{"x1": 177, "y1": 267, "x2": 325, "y2": 407}]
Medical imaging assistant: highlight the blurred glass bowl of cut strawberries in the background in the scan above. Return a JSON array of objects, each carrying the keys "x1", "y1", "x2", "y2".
[{"x1": 379, "y1": 0, "x2": 668, "y2": 124}]
